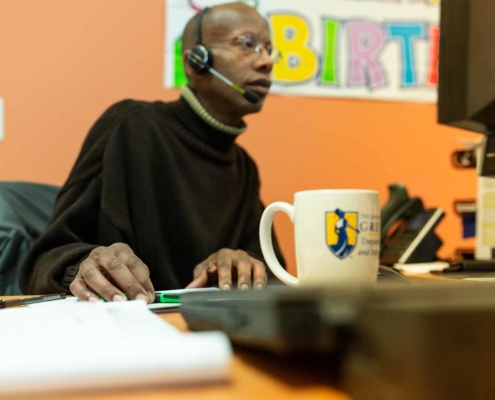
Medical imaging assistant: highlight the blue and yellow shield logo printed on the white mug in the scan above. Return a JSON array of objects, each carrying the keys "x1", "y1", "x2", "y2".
[{"x1": 326, "y1": 208, "x2": 359, "y2": 260}]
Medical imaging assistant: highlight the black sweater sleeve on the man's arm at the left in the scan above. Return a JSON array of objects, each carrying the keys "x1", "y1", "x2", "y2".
[{"x1": 19, "y1": 101, "x2": 137, "y2": 294}]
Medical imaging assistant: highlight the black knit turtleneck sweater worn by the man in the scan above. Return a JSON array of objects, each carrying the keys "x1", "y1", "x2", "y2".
[{"x1": 20, "y1": 98, "x2": 283, "y2": 294}]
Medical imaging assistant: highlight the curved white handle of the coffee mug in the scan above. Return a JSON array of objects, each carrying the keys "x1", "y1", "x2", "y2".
[{"x1": 260, "y1": 201, "x2": 299, "y2": 287}]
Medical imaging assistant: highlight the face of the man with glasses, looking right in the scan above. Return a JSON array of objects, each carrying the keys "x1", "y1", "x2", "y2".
[{"x1": 189, "y1": 9, "x2": 273, "y2": 115}]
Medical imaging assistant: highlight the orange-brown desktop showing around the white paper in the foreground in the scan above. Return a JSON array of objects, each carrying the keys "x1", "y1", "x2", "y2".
[{"x1": 0, "y1": 297, "x2": 350, "y2": 400}]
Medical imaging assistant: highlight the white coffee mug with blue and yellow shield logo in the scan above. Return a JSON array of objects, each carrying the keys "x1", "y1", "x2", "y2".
[{"x1": 260, "y1": 189, "x2": 380, "y2": 287}]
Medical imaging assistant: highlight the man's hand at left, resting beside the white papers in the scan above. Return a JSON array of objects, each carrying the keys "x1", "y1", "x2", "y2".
[{"x1": 70, "y1": 243, "x2": 155, "y2": 303}]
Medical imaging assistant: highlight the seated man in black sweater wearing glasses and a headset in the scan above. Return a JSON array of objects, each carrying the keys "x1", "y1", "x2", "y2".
[{"x1": 20, "y1": 3, "x2": 282, "y2": 302}]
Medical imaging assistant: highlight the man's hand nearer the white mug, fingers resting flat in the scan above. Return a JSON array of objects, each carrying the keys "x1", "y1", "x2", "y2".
[{"x1": 187, "y1": 249, "x2": 267, "y2": 290}]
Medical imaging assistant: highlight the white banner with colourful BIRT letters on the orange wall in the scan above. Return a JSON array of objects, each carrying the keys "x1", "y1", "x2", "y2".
[{"x1": 164, "y1": 0, "x2": 440, "y2": 103}]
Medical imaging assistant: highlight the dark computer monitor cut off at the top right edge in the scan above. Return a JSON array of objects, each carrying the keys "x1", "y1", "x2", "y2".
[{"x1": 438, "y1": 0, "x2": 495, "y2": 177}]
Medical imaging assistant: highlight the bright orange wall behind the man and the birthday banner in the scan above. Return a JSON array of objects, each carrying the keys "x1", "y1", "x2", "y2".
[{"x1": 0, "y1": 0, "x2": 476, "y2": 269}]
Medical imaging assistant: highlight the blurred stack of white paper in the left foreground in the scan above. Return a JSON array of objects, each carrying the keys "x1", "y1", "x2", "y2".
[{"x1": 0, "y1": 301, "x2": 231, "y2": 397}]
